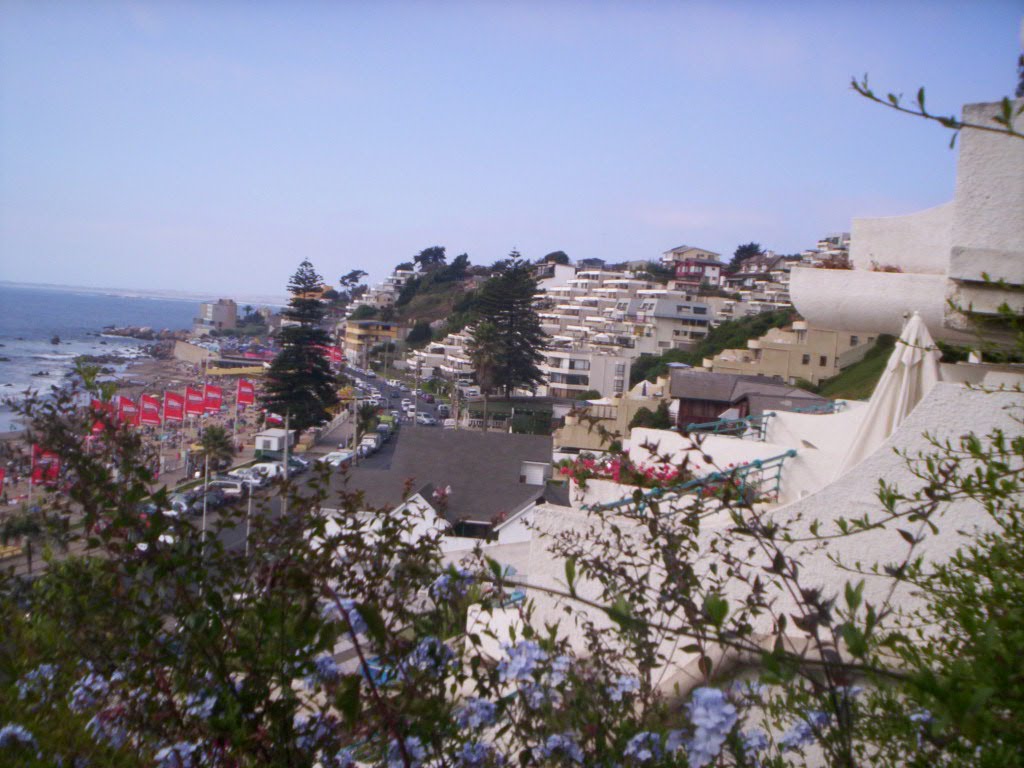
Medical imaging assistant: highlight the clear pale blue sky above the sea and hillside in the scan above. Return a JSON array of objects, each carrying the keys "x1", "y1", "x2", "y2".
[{"x1": 0, "y1": 0, "x2": 1024, "y2": 296}]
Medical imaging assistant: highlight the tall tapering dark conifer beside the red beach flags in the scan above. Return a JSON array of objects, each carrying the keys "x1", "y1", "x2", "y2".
[{"x1": 263, "y1": 261, "x2": 338, "y2": 432}]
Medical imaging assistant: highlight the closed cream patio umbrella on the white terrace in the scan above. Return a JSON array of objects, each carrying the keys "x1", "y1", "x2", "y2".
[{"x1": 837, "y1": 312, "x2": 940, "y2": 477}]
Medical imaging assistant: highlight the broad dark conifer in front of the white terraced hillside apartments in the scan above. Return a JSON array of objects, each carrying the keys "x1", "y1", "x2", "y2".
[{"x1": 476, "y1": 257, "x2": 547, "y2": 397}]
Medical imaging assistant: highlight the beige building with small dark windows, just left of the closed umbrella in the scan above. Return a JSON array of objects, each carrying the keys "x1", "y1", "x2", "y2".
[{"x1": 703, "y1": 321, "x2": 878, "y2": 385}]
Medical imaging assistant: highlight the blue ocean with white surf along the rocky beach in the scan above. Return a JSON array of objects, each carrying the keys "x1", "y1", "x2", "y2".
[{"x1": 0, "y1": 284, "x2": 201, "y2": 432}]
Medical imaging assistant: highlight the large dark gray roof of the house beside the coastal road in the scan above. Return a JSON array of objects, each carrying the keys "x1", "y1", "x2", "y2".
[{"x1": 339, "y1": 426, "x2": 551, "y2": 522}]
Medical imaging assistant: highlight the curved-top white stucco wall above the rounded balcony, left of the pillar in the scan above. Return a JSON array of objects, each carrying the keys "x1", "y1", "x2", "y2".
[{"x1": 850, "y1": 203, "x2": 953, "y2": 274}]
